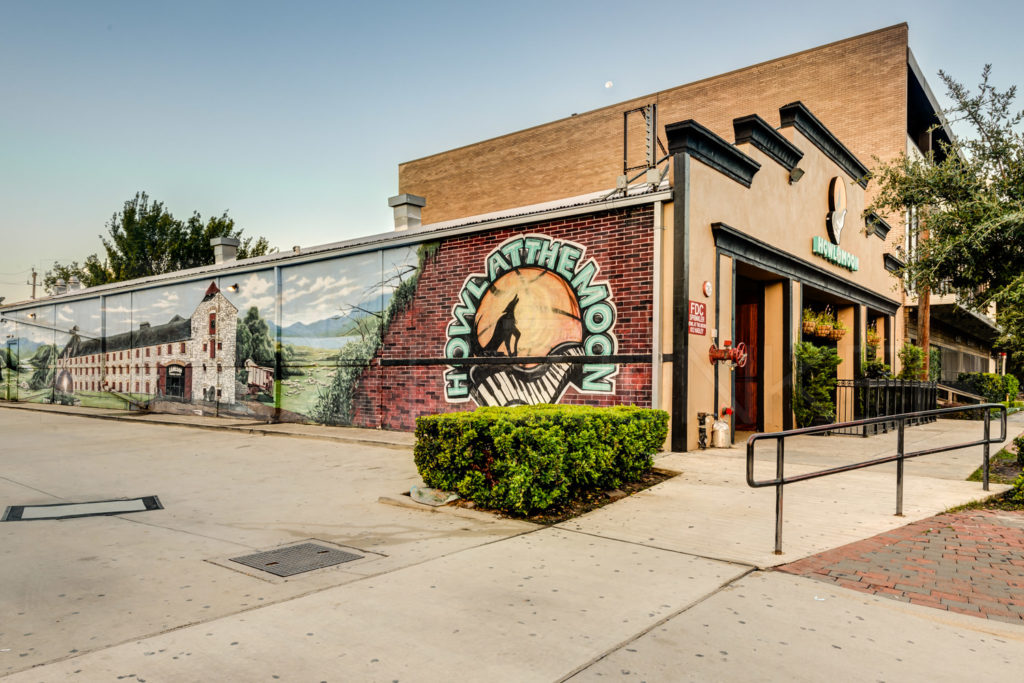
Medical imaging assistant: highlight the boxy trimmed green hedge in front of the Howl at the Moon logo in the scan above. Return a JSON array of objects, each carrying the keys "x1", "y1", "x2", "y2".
[{"x1": 414, "y1": 404, "x2": 669, "y2": 515}]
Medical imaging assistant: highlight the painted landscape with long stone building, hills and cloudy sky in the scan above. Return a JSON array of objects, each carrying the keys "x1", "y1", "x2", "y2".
[{"x1": 0, "y1": 246, "x2": 424, "y2": 425}]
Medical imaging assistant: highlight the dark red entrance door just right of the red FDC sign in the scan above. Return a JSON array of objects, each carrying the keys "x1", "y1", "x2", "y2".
[{"x1": 733, "y1": 278, "x2": 764, "y2": 431}]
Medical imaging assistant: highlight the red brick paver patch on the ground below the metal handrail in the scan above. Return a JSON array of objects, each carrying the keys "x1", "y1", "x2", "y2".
[{"x1": 778, "y1": 510, "x2": 1024, "y2": 623}]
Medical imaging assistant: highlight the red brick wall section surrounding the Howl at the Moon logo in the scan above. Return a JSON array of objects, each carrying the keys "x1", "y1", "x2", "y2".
[{"x1": 353, "y1": 205, "x2": 653, "y2": 430}]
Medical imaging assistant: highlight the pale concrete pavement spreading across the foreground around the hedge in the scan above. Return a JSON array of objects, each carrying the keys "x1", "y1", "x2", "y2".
[{"x1": 0, "y1": 403, "x2": 1024, "y2": 681}]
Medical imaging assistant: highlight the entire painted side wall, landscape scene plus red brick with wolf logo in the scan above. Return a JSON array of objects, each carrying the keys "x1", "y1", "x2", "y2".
[{"x1": 0, "y1": 202, "x2": 653, "y2": 429}]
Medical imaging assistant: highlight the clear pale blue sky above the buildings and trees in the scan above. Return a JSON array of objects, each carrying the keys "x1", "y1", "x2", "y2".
[{"x1": 0, "y1": 0, "x2": 1024, "y2": 303}]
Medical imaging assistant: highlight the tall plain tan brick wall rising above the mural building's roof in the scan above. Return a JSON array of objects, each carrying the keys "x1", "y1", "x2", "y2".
[{"x1": 398, "y1": 24, "x2": 907, "y2": 225}]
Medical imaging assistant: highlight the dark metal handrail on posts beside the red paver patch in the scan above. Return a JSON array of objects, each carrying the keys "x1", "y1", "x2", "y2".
[{"x1": 746, "y1": 403, "x2": 1007, "y2": 555}]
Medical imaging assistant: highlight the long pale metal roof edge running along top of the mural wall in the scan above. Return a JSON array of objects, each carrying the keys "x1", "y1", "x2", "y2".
[{"x1": 0, "y1": 179, "x2": 672, "y2": 312}]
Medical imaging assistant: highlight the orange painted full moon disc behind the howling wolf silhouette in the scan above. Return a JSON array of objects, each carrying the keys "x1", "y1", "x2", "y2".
[{"x1": 476, "y1": 268, "x2": 583, "y2": 356}]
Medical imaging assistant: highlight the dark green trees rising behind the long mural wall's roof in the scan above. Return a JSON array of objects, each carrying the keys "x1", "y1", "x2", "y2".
[{"x1": 43, "y1": 193, "x2": 270, "y2": 293}]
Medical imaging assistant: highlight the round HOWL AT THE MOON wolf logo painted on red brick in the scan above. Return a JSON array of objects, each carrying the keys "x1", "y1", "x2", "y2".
[{"x1": 444, "y1": 234, "x2": 618, "y2": 405}]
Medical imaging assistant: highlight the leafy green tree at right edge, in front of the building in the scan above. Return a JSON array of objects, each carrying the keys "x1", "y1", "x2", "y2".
[{"x1": 870, "y1": 65, "x2": 1024, "y2": 378}]
